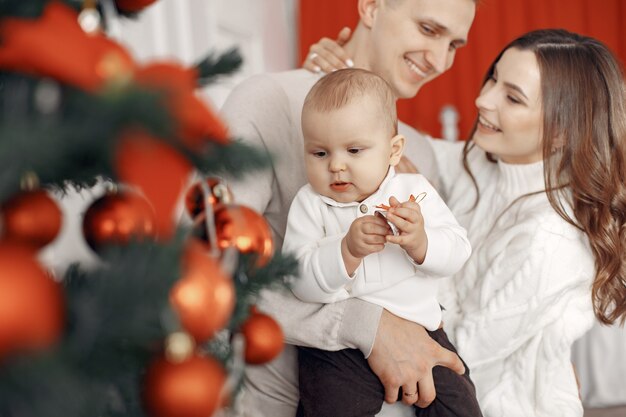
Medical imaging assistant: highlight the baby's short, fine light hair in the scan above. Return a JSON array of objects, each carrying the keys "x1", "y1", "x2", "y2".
[{"x1": 302, "y1": 68, "x2": 398, "y2": 135}]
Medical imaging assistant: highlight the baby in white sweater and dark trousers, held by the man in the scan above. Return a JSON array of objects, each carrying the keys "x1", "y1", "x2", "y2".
[{"x1": 283, "y1": 69, "x2": 481, "y2": 417}]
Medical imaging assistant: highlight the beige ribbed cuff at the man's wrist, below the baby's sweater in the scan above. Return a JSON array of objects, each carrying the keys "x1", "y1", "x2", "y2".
[{"x1": 337, "y1": 298, "x2": 383, "y2": 358}]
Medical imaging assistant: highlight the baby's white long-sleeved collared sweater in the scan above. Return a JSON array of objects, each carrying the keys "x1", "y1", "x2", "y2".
[{"x1": 283, "y1": 168, "x2": 471, "y2": 331}]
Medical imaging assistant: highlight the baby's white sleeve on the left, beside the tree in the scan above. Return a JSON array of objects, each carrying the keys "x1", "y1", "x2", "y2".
[{"x1": 283, "y1": 186, "x2": 354, "y2": 303}]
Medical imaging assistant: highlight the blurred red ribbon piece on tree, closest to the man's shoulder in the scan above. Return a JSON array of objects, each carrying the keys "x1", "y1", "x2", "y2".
[{"x1": 135, "y1": 62, "x2": 229, "y2": 150}]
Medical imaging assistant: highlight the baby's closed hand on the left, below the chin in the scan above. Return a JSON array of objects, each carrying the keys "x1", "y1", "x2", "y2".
[{"x1": 344, "y1": 216, "x2": 391, "y2": 259}]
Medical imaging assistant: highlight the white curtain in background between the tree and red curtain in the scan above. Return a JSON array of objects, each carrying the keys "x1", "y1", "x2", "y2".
[{"x1": 110, "y1": 0, "x2": 297, "y2": 107}]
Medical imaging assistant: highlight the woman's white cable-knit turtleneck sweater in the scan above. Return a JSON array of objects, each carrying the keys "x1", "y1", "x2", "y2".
[{"x1": 434, "y1": 142, "x2": 594, "y2": 417}]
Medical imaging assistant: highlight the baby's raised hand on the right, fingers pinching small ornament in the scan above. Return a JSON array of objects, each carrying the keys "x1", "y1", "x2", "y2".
[{"x1": 386, "y1": 197, "x2": 428, "y2": 263}]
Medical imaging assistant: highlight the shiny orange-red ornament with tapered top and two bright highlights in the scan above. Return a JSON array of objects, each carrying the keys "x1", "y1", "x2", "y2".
[{"x1": 170, "y1": 241, "x2": 235, "y2": 343}]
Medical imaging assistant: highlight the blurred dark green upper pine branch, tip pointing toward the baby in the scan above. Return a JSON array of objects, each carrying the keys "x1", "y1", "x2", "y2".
[{"x1": 0, "y1": 73, "x2": 270, "y2": 201}]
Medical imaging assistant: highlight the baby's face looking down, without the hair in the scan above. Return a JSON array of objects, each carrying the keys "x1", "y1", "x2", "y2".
[{"x1": 302, "y1": 96, "x2": 392, "y2": 203}]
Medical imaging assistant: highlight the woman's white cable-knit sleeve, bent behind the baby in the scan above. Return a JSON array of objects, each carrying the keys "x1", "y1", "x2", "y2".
[{"x1": 456, "y1": 219, "x2": 593, "y2": 366}]
